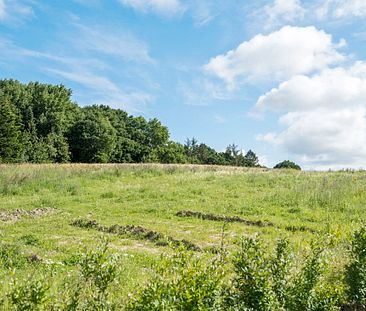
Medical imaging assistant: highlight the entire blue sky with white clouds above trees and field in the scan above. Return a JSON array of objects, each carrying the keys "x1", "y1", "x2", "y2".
[{"x1": 0, "y1": 0, "x2": 366, "y2": 170}]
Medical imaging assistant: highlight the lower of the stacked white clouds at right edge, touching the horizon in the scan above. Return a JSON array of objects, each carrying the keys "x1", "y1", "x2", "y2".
[{"x1": 258, "y1": 107, "x2": 366, "y2": 168}]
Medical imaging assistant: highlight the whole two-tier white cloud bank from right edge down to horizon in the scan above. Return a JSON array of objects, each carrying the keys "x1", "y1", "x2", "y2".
[{"x1": 257, "y1": 62, "x2": 366, "y2": 168}]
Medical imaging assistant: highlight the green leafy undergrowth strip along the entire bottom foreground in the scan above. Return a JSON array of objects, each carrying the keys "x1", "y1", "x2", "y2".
[{"x1": 0, "y1": 228, "x2": 366, "y2": 311}]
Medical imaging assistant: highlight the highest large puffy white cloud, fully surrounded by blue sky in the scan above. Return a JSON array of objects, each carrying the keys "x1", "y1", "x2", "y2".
[{"x1": 204, "y1": 26, "x2": 345, "y2": 88}]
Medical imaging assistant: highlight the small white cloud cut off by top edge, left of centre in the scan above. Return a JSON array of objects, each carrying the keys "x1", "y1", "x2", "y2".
[{"x1": 119, "y1": 0, "x2": 184, "y2": 16}]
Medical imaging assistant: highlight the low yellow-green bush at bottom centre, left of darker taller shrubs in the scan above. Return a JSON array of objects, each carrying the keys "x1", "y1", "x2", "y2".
[{"x1": 126, "y1": 245, "x2": 225, "y2": 311}]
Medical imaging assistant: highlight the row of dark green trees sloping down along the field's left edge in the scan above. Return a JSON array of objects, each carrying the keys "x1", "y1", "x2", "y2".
[{"x1": 0, "y1": 80, "x2": 298, "y2": 167}]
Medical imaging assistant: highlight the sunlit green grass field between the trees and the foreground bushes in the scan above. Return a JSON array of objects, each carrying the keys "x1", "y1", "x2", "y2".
[{"x1": 0, "y1": 165, "x2": 366, "y2": 308}]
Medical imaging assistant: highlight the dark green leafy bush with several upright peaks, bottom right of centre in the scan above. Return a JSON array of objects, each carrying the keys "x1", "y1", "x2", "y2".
[{"x1": 224, "y1": 237, "x2": 339, "y2": 311}]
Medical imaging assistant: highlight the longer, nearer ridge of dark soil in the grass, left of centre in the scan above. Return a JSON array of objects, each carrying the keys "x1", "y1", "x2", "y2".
[{"x1": 71, "y1": 219, "x2": 201, "y2": 251}]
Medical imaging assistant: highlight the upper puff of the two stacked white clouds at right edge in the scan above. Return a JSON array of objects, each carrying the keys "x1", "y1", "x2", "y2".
[{"x1": 257, "y1": 62, "x2": 366, "y2": 111}]
